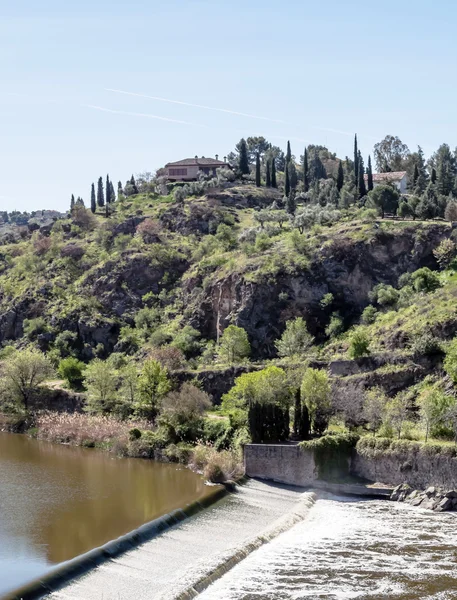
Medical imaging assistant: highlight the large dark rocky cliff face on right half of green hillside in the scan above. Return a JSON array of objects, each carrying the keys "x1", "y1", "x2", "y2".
[{"x1": 184, "y1": 224, "x2": 449, "y2": 356}]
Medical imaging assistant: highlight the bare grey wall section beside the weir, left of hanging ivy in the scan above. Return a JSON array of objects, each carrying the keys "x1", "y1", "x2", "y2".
[{"x1": 244, "y1": 444, "x2": 317, "y2": 486}]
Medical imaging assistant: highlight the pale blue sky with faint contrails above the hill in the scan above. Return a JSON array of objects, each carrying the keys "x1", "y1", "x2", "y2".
[{"x1": 0, "y1": 0, "x2": 457, "y2": 211}]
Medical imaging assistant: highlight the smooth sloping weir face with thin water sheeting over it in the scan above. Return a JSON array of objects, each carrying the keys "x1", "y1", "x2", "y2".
[{"x1": 41, "y1": 480, "x2": 306, "y2": 600}]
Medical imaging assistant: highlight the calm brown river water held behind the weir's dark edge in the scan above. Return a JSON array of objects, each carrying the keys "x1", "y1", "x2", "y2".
[{"x1": 0, "y1": 433, "x2": 209, "y2": 597}]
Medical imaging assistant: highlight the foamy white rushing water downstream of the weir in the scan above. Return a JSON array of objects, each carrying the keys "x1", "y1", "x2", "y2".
[{"x1": 199, "y1": 498, "x2": 457, "y2": 600}]
